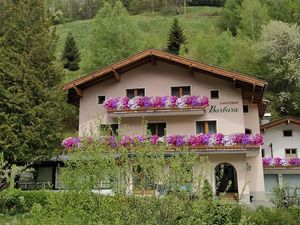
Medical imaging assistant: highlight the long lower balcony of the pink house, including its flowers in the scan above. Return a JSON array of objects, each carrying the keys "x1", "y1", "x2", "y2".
[{"x1": 62, "y1": 133, "x2": 263, "y2": 155}]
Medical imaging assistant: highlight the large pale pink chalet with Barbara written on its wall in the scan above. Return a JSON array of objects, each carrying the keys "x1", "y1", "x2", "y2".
[{"x1": 21, "y1": 49, "x2": 267, "y2": 203}]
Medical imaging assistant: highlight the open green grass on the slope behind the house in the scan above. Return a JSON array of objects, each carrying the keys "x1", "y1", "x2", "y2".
[{"x1": 56, "y1": 7, "x2": 221, "y2": 82}]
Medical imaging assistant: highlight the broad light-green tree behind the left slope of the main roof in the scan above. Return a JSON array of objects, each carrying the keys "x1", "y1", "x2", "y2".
[{"x1": 90, "y1": 1, "x2": 139, "y2": 68}]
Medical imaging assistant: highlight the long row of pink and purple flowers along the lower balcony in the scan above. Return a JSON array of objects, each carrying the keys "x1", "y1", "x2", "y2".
[{"x1": 62, "y1": 133, "x2": 263, "y2": 149}]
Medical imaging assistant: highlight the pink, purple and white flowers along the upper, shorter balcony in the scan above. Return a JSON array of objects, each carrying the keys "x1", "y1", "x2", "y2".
[{"x1": 104, "y1": 95, "x2": 208, "y2": 110}]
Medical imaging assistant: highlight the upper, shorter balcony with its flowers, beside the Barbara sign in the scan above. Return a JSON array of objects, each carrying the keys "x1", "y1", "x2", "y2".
[{"x1": 104, "y1": 96, "x2": 209, "y2": 118}]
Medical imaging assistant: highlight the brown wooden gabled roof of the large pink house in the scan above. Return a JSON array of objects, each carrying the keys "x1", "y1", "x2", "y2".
[{"x1": 63, "y1": 49, "x2": 267, "y2": 105}]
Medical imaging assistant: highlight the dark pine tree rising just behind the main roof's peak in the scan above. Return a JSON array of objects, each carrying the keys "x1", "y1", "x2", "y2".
[{"x1": 167, "y1": 18, "x2": 186, "y2": 55}]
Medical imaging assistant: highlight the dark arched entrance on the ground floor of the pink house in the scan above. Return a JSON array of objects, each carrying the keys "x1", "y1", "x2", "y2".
[{"x1": 215, "y1": 163, "x2": 238, "y2": 195}]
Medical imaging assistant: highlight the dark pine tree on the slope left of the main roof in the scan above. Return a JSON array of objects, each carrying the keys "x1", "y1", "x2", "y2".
[{"x1": 61, "y1": 32, "x2": 80, "y2": 71}]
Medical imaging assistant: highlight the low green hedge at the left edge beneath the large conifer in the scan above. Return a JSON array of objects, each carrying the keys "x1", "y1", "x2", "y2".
[{"x1": 0, "y1": 189, "x2": 53, "y2": 215}]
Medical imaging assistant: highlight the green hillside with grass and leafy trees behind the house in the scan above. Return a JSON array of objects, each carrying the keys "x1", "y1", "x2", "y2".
[{"x1": 48, "y1": 0, "x2": 300, "y2": 117}]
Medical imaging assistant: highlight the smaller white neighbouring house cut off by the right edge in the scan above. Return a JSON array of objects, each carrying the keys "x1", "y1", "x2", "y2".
[{"x1": 260, "y1": 117, "x2": 300, "y2": 195}]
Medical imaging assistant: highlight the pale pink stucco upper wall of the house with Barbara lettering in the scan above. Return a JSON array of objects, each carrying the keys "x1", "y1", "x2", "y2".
[{"x1": 79, "y1": 62, "x2": 259, "y2": 135}]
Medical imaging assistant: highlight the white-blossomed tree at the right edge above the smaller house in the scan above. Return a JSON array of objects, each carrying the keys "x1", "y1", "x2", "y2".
[{"x1": 258, "y1": 21, "x2": 300, "y2": 115}]
